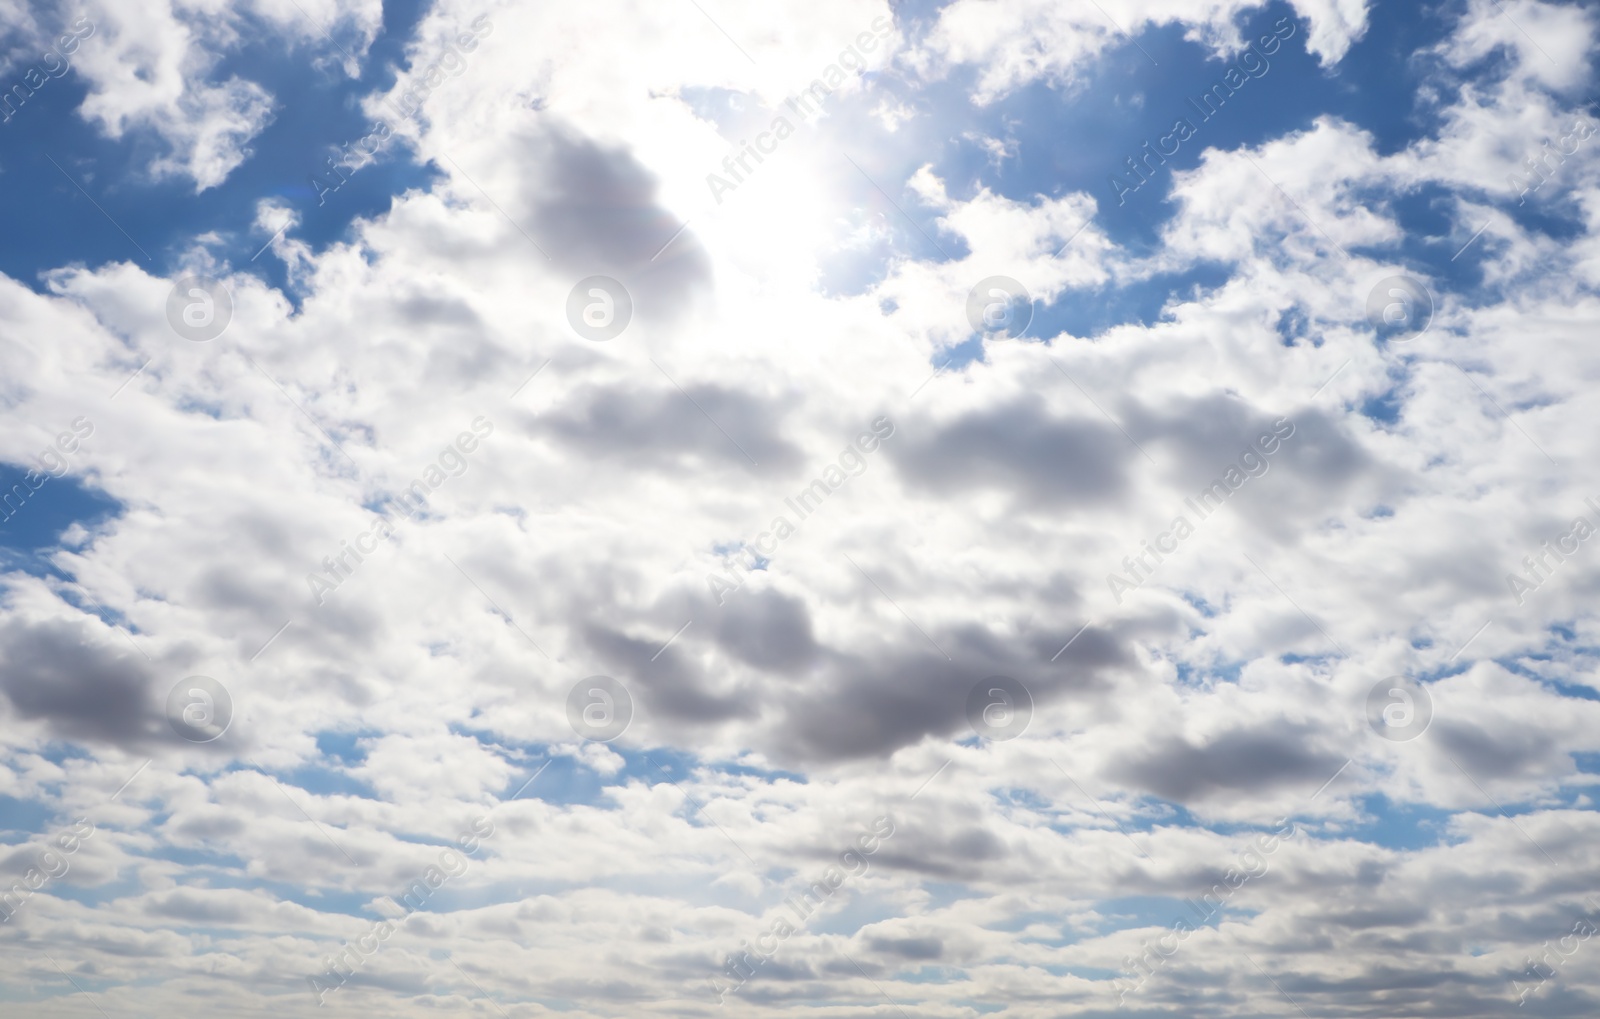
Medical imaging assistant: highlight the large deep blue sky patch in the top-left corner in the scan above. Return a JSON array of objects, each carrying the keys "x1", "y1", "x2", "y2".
[{"x1": 0, "y1": 0, "x2": 438, "y2": 300}]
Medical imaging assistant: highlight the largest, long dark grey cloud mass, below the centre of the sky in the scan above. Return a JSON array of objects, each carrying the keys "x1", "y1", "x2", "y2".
[{"x1": 576, "y1": 572, "x2": 1133, "y2": 765}]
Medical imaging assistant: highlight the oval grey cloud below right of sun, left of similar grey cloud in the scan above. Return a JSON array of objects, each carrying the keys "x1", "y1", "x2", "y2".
[{"x1": 885, "y1": 395, "x2": 1139, "y2": 507}]
